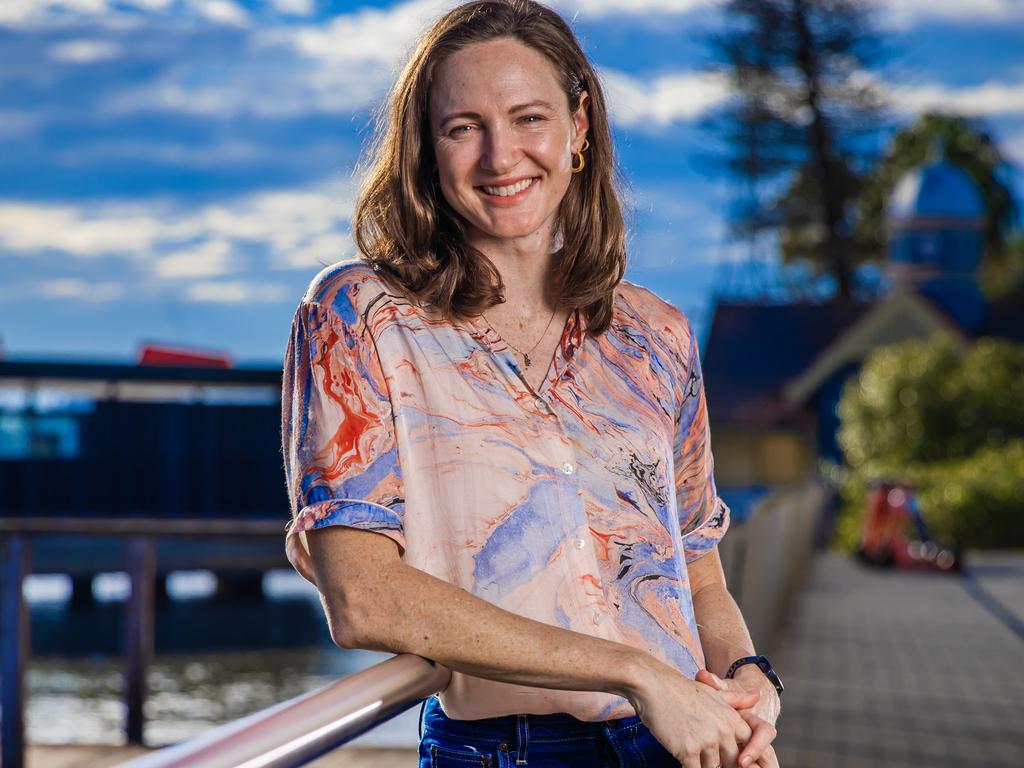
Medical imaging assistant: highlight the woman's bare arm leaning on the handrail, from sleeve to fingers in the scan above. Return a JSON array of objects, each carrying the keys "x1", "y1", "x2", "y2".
[{"x1": 306, "y1": 526, "x2": 757, "y2": 768}]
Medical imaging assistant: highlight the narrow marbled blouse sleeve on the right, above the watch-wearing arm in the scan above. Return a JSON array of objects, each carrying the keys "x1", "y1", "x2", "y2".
[{"x1": 674, "y1": 321, "x2": 729, "y2": 562}]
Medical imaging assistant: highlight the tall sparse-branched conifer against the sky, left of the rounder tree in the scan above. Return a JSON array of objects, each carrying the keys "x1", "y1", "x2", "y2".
[{"x1": 710, "y1": 0, "x2": 881, "y2": 299}]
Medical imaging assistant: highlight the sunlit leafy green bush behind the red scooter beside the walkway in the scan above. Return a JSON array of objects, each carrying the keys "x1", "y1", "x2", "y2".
[{"x1": 837, "y1": 335, "x2": 1024, "y2": 548}]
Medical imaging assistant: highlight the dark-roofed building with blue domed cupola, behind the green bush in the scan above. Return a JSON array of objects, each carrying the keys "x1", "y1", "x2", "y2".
[{"x1": 703, "y1": 151, "x2": 1024, "y2": 516}]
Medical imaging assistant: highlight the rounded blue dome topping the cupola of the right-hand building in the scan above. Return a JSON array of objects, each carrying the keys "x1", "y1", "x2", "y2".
[{"x1": 888, "y1": 161, "x2": 985, "y2": 223}]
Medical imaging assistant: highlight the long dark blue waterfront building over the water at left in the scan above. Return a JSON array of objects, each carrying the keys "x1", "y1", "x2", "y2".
[{"x1": 0, "y1": 355, "x2": 289, "y2": 590}]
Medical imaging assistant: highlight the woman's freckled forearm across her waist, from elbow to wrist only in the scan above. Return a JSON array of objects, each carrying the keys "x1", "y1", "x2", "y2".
[{"x1": 325, "y1": 562, "x2": 659, "y2": 701}]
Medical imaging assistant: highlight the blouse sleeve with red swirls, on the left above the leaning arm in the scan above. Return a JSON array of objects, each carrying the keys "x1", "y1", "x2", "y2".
[{"x1": 281, "y1": 295, "x2": 406, "y2": 583}]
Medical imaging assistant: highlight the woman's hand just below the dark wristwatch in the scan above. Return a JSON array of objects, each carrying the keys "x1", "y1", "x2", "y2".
[{"x1": 694, "y1": 667, "x2": 779, "y2": 768}]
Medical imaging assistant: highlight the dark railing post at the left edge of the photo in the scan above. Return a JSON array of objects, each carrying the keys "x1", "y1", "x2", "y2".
[{"x1": 0, "y1": 534, "x2": 31, "y2": 768}]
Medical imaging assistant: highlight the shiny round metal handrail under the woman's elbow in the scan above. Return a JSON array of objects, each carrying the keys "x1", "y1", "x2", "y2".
[{"x1": 115, "y1": 654, "x2": 452, "y2": 768}]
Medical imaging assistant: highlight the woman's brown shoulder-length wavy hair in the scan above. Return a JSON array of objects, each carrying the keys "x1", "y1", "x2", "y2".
[{"x1": 352, "y1": 0, "x2": 626, "y2": 336}]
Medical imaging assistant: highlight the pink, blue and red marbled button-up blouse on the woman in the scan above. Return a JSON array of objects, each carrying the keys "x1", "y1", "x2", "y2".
[{"x1": 282, "y1": 261, "x2": 729, "y2": 721}]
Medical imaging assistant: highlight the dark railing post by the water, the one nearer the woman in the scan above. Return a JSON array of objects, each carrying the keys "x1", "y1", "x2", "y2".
[{"x1": 125, "y1": 537, "x2": 156, "y2": 744}]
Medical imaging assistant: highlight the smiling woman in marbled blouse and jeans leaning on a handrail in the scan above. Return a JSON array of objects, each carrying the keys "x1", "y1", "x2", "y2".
[{"x1": 283, "y1": 0, "x2": 778, "y2": 768}]
